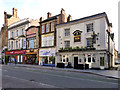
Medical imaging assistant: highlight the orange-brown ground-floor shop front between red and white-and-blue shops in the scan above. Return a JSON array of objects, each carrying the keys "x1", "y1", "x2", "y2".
[{"x1": 25, "y1": 49, "x2": 39, "y2": 65}]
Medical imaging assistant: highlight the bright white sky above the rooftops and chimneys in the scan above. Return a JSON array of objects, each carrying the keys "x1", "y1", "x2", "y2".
[{"x1": 0, "y1": 0, "x2": 120, "y2": 50}]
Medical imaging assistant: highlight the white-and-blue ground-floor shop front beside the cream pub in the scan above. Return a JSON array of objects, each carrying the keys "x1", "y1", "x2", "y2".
[{"x1": 39, "y1": 48, "x2": 56, "y2": 66}]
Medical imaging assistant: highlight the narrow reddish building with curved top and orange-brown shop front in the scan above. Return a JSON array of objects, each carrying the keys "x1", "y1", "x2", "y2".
[{"x1": 25, "y1": 26, "x2": 39, "y2": 65}]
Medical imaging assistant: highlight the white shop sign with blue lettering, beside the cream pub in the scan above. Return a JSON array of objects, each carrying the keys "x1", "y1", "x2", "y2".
[{"x1": 39, "y1": 49, "x2": 56, "y2": 56}]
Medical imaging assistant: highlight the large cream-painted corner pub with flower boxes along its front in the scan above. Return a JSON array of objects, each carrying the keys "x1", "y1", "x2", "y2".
[{"x1": 56, "y1": 13, "x2": 114, "y2": 68}]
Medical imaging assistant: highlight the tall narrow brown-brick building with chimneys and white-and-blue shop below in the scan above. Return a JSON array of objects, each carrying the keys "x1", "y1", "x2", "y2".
[{"x1": 39, "y1": 9, "x2": 67, "y2": 66}]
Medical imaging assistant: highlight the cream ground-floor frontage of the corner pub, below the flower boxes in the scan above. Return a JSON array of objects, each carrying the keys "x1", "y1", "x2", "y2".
[{"x1": 56, "y1": 50, "x2": 108, "y2": 69}]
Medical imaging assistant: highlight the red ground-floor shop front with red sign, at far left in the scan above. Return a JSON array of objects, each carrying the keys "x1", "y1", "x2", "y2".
[{"x1": 5, "y1": 50, "x2": 25, "y2": 64}]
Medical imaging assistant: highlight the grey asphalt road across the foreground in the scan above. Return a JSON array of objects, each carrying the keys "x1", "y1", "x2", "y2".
[{"x1": 2, "y1": 65, "x2": 118, "y2": 88}]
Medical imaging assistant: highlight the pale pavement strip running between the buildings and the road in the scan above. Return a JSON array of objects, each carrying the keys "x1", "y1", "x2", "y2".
[{"x1": 6, "y1": 64, "x2": 120, "y2": 79}]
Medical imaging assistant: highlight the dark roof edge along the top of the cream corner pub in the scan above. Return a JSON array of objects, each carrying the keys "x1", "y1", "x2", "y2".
[{"x1": 57, "y1": 12, "x2": 111, "y2": 26}]
